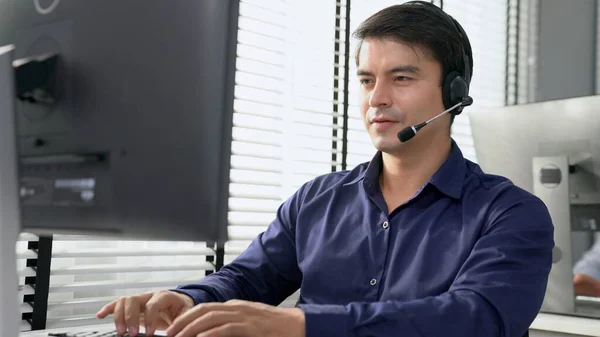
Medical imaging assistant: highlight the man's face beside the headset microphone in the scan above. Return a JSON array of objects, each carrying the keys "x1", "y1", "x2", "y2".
[{"x1": 357, "y1": 39, "x2": 450, "y2": 153}]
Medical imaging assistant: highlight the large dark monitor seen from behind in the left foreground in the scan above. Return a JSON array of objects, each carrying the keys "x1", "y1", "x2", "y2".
[{"x1": 0, "y1": 0, "x2": 239, "y2": 242}]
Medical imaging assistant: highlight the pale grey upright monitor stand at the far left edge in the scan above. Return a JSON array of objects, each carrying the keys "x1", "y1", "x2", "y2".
[{"x1": 0, "y1": 46, "x2": 21, "y2": 337}]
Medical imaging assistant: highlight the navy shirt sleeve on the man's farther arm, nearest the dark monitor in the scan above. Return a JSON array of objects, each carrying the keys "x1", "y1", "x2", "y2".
[{"x1": 173, "y1": 185, "x2": 306, "y2": 305}]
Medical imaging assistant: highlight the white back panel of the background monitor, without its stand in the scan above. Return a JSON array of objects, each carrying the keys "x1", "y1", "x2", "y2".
[{"x1": 469, "y1": 96, "x2": 600, "y2": 193}]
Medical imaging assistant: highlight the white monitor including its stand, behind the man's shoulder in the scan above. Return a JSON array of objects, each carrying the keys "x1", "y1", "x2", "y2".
[{"x1": 469, "y1": 96, "x2": 600, "y2": 317}]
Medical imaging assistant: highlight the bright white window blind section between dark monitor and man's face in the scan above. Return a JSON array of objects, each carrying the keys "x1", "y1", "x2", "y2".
[{"x1": 224, "y1": 0, "x2": 343, "y2": 306}]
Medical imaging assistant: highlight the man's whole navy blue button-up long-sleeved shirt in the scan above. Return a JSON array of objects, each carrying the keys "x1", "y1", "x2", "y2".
[{"x1": 178, "y1": 142, "x2": 554, "y2": 337}]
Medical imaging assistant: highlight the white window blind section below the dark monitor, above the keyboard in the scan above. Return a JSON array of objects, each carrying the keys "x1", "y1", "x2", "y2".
[{"x1": 46, "y1": 235, "x2": 215, "y2": 329}]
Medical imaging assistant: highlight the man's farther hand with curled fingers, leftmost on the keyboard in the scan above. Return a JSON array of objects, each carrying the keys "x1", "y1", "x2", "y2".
[{"x1": 96, "y1": 291, "x2": 194, "y2": 336}]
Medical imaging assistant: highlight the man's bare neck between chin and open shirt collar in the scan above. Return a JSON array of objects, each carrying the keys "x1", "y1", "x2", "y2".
[{"x1": 380, "y1": 137, "x2": 452, "y2": 197}]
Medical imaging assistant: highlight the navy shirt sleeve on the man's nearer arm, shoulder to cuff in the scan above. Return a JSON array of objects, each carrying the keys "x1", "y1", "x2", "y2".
[{"x1": 300, "y1": 197, "x2": 554, "y2": 337}]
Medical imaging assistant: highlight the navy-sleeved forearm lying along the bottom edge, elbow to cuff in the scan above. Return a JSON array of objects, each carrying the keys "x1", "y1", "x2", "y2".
[{"x1": 300, "y1": 290, "x2": 516, "y2": 337}]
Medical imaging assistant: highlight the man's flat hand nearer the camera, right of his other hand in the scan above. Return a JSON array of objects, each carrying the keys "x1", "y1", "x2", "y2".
[{"x1": 167, "y1": 300, "x2": 305, "y2": 337}]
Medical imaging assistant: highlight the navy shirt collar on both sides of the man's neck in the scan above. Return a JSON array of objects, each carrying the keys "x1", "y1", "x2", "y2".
[{"x1": 344, "y1": 140, "x2": 466, "y2": 199}]
